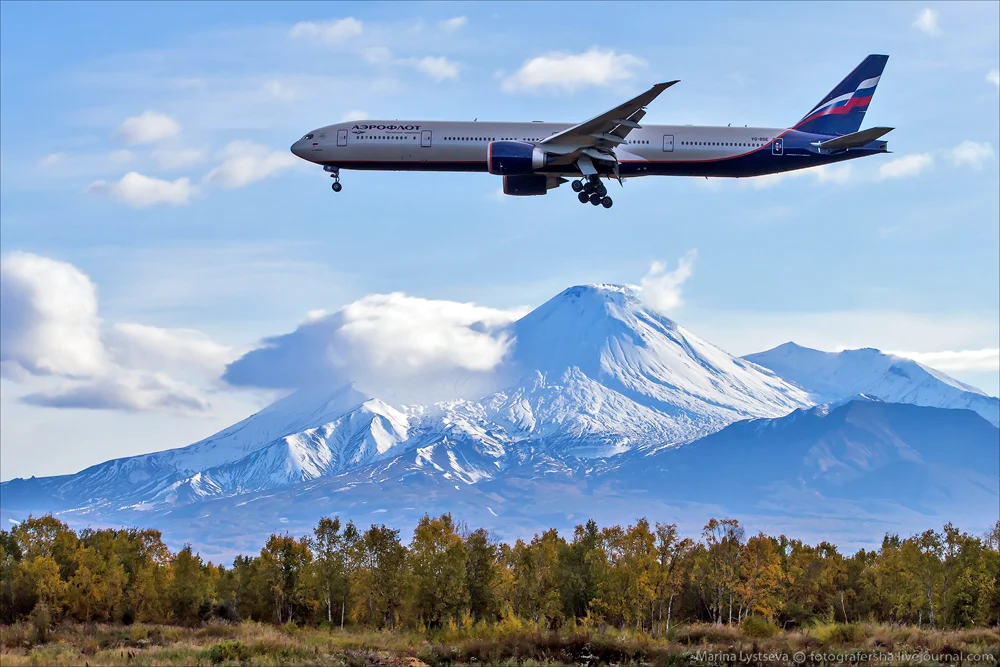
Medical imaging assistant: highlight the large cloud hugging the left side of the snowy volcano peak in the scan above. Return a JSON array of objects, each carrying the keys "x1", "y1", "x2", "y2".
[{"x1": 223, "y1": 293, "x2": 523, "y2": 401}]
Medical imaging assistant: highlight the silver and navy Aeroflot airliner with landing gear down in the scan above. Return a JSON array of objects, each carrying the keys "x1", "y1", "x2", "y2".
[{"x1": 291, "y1": 55, "x2": 893, "y2": 208}]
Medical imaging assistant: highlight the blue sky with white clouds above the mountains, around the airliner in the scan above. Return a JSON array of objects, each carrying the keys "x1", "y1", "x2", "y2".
[{"x1": 0, "y1": 2, "x2": 1000, "y2": 479}]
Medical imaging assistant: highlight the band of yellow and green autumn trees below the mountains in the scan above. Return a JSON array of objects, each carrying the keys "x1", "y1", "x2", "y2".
[{"x1": 0, "y1": 514, "x2": 1000, "y2": 637}]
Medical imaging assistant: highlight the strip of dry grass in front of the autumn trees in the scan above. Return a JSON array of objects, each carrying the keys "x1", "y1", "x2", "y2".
[{"x1": 0, "y1": 623, "x2": 1000, "y2": 667}]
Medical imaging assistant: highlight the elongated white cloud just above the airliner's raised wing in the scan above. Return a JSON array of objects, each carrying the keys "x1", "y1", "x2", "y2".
[{"x1": 502, "y1": 49, "x2": 646, "y2": 93}]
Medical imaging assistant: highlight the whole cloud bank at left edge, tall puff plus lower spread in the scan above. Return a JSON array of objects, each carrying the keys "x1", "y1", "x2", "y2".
[{"x1": 0, "y1": 252, "x2": 232, "y2": 413}]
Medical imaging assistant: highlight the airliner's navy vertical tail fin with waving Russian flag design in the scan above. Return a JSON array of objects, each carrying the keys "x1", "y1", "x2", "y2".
[{"x1": 795, "y1": 55, "x2": 889, "y2": 135}]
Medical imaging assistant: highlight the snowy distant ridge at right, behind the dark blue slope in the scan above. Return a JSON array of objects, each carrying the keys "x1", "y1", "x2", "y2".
[{"x1": 744, "y1": 343, "x2": 1000, "y2": 426}]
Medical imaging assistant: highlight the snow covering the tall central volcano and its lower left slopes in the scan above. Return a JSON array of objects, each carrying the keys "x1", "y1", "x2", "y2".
[{"x1": 4, "y1": 285, "x2": 809, "y2": 509}]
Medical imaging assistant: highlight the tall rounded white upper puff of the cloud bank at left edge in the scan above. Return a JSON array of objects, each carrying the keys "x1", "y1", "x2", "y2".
[{"x1": 0, "y1": 252, "x2": 107, "y2": 377}]
